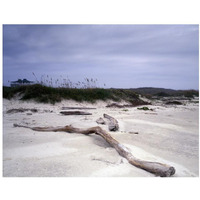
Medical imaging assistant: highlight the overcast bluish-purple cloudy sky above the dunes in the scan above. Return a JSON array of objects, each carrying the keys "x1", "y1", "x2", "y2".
[{"x1": 3, "y1": 25, "x2": 199, "y2": 89}]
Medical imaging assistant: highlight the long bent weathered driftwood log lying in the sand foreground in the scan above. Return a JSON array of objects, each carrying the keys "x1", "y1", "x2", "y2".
[{"x1": 14, "y1": 124, "x2": 175, "y2": 177}]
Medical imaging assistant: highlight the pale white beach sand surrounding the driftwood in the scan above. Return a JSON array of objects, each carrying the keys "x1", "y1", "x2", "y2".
[{"x1": 3, "y1": 99, "x2": 199, "y2": 177}]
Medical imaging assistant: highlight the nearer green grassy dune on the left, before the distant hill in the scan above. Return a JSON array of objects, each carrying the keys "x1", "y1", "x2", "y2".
[{"x1": 3, "y1": 84, "x2": 138, "y2": 104}]
